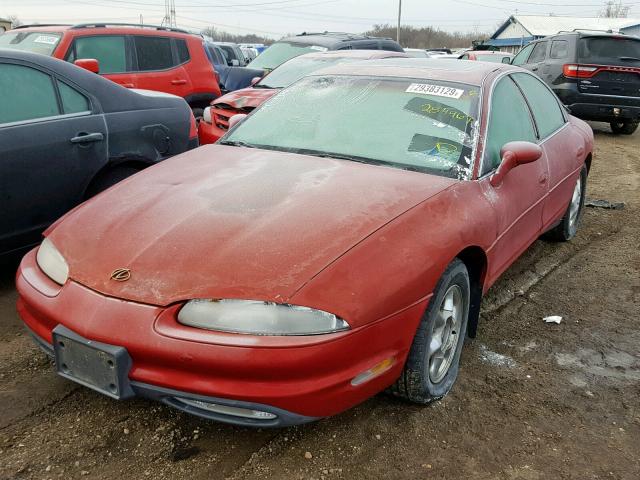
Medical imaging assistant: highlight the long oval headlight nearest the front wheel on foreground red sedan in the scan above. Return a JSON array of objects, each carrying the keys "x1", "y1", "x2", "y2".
[{"x1": 178, "y1": 300, "x2": 349, "y2": 335}]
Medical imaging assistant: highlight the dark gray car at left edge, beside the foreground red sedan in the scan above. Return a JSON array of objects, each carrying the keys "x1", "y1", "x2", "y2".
[{"x1": 0, "y1": 50, "x2": 197, "y2": 257}]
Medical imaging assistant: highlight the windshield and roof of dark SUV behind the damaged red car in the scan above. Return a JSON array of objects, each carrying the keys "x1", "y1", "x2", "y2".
[{"x1": 247, "y1": 32, "x2": 404, "y2": 71}]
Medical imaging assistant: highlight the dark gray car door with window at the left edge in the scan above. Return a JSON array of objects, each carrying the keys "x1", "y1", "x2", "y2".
[{"x1": 0, "y1": 61, "x2": 107, "y2": 253}]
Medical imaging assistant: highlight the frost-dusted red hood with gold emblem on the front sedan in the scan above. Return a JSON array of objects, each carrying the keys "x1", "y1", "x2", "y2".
[{"x1": 48, "y1": 145, "x2": 455, "y2": 305}]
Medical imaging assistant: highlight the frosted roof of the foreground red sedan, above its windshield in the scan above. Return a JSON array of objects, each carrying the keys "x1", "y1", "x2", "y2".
[{"x1": 313, "y1": 58, "x2": 510, "y2": 86}]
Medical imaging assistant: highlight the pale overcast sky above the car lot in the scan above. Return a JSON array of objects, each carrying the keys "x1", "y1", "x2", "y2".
[{"x1": 0, "y1": 0, "x2": 640, "y2": 38}]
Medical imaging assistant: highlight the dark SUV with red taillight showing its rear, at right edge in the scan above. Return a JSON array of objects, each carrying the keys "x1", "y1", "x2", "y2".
[{"x1": 511, "y1": 31, "x2": 640, "y2": 135}]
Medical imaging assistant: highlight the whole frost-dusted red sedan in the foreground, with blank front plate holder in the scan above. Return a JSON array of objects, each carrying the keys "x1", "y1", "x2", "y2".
[{"x1": 17, "y1": 59, "x2": 593, "y2": 426}]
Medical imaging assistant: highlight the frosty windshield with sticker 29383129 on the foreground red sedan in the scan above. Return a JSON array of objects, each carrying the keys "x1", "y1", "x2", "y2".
[{"x1": 225, "y1": 76, "x2": 479, "y2": 179}]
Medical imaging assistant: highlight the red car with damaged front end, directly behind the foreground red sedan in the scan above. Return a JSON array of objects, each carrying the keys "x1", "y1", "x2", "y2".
[{"x1": 198, "y1": 50, "x2": 407, "y2": 145}]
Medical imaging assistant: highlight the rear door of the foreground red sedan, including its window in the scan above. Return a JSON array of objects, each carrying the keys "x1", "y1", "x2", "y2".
[{"x1": 513, "y1": 73, "x2": 585, "y2": 230}]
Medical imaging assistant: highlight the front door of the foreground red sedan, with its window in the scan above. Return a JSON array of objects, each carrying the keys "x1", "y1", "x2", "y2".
[{"x1": 479, "y1": 76, "x2": 548, "y2": 282}]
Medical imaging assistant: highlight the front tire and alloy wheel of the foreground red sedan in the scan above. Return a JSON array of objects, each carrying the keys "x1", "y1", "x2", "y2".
[{"x1": 389, "y1": 259, "x2": 470, "y2": 404}]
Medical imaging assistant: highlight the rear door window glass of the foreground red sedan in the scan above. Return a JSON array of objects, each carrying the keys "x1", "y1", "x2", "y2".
[{"x1": 513, "y1": 73, "x2": 565, "y2": 138}]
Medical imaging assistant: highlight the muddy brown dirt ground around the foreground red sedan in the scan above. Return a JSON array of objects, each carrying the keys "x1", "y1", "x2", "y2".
[{"x1": 0, "y1": 124, "x2": 640, "y2": 480}]
